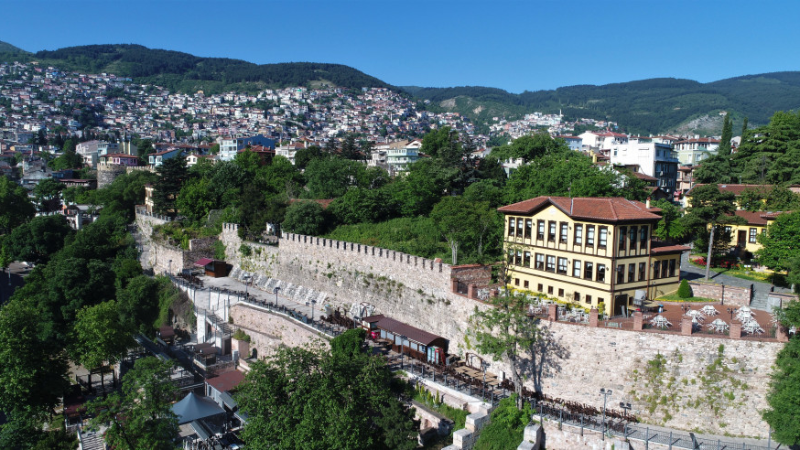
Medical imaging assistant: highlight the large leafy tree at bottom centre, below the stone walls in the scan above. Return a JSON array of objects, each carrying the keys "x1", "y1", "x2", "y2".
[{"x1": 236, "y1": 335, "x2": 417, "y2": 450}]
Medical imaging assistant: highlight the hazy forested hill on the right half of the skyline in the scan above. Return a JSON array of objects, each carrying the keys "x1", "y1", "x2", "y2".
[{"x1": 402, "y1": 72, "x2": 800, "y2": 133}]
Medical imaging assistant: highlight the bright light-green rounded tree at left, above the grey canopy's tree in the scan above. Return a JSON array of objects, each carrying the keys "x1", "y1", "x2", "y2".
[{"x1": 70, "y1": 300, "x2": 135, "y2": 369}]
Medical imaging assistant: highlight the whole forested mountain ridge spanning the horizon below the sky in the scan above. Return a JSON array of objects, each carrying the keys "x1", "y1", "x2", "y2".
[{"x1": 0, "y1": 41, "x2": 800, "y2": 134}]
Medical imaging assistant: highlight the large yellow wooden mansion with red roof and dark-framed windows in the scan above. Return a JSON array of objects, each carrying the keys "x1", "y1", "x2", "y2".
[{"x1": 498, "y1": 197, "x2": 689, "y2": 314}]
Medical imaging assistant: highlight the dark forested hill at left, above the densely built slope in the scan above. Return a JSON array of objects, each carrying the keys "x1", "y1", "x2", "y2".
[{"x1": 0, "y1": 44, "x2": 391, "y2": 93}]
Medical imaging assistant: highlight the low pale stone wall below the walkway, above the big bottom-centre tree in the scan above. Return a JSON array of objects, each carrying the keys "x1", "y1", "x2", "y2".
[{"x1": 230, "y1": 303, "x2": 328, "y2": 358}]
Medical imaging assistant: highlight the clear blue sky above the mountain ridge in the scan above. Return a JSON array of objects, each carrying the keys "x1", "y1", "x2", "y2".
[{"x1": 0, "y1": 0, "x2": 800, "y2": 92}]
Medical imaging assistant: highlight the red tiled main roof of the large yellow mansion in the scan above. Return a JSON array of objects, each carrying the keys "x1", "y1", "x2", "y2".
[{"x1": 497, "y1": 197, "x2": 661, "y2": 222}]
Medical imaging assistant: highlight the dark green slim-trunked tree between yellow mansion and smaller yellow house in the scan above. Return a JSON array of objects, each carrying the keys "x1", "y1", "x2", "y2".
[{"x1": 683, "y1": 184, "x2": 746, "y2": 281}]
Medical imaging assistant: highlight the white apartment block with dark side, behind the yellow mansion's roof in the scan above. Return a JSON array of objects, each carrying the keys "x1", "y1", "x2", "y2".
[{"x1": 609, "y1": 137, "x2": 678, "y2": 194}]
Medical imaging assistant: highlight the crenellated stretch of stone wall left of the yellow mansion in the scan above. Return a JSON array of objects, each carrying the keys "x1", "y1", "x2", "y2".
[{"x1": 272, "y1": 233, "x2": 486, "y2": 356}]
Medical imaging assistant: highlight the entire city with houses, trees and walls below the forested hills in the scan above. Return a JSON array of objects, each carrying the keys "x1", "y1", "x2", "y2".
[{"x1": 0, "y1": 54, "x2": 800, "y2": 450}]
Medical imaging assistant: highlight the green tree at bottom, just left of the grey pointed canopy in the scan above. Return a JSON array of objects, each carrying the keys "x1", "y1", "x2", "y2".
[{"x1": 88, "y1": 357, "x2": 178, "y2": 450}]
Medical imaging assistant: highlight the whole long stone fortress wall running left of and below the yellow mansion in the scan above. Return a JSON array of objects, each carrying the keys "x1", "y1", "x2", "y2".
[{"x1": 137, "y1": 216, "x2": 783, "y2": 437}]
